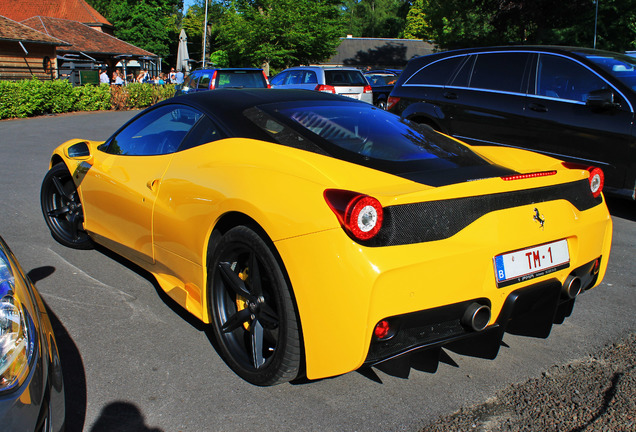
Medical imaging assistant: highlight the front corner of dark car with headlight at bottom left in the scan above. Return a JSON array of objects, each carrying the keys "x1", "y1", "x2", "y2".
[{"x1": 0, "y1": 238, "x2": 65, "y2": 432}]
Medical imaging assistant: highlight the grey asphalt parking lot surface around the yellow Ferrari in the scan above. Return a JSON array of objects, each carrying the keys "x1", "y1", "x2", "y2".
[{"x1": 0, "y1": 112, "x2": 636, "y2": 431}]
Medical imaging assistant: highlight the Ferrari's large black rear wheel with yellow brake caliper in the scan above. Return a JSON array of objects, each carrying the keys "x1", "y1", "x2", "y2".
[{"x1": 208, "y1": 226, "x2": 301, "y2": 386}]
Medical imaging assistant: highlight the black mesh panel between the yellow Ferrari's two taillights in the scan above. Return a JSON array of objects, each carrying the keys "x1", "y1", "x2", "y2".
[{"x1": 361, "y1": 180, "x2": 602, "y2": 247}]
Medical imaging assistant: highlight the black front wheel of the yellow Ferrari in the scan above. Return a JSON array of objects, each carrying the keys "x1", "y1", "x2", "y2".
[{"x1": 40, "y1": 163, "x2": 93, "y2": 249}]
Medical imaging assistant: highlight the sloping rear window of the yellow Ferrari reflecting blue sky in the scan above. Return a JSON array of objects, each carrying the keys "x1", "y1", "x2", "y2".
[{"x1": 246, "y1": 103, "x2": 488, "y2": 173}]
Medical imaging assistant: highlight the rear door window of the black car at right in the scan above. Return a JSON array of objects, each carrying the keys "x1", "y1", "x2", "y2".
[{"x1": 470, "y1": 52, "x2": 529, "y2": 93}]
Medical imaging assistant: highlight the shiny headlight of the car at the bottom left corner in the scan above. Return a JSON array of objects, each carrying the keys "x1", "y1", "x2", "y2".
[{"x1": 0, "y1": 249, "x2": 36, "y2": 393}]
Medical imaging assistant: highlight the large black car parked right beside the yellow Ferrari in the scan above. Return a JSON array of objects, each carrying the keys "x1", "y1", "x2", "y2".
[{"x1": 389, "y1": 46, "x2": 636, "y2": 199}]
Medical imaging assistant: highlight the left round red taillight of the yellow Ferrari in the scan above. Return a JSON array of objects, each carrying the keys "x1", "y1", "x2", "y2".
[{"x1": 324, "y1": 189, "x2": 384, "y2": 240}]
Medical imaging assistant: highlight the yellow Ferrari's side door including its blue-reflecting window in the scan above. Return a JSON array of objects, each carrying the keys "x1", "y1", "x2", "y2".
[{"x1": 80, "y1": 104, "x2": 201, "y2": 263}]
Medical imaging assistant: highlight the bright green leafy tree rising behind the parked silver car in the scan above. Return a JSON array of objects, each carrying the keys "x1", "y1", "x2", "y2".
[{"x1": 218, "y1": 0, "x2": 342, "y2": 73}]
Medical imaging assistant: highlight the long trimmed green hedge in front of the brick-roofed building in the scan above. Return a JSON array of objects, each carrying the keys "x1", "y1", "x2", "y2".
[{"x1": 0, "y1": 79, "x2": 175, "y2": 119}]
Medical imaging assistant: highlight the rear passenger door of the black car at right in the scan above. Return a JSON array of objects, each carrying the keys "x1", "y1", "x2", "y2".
[{"x1": 442, "y1": 51, "x2": 531, "y2": 146}]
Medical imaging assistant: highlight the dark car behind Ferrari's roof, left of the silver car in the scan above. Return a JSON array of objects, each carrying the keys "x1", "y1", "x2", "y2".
[{"x1": 176, "y1": 68, "x2": 269, "y2": 96}]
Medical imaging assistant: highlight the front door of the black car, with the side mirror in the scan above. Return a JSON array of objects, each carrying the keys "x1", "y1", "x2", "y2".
[{"x1": 525, "y1": 53, "x2": 634, "y2": 185}]
